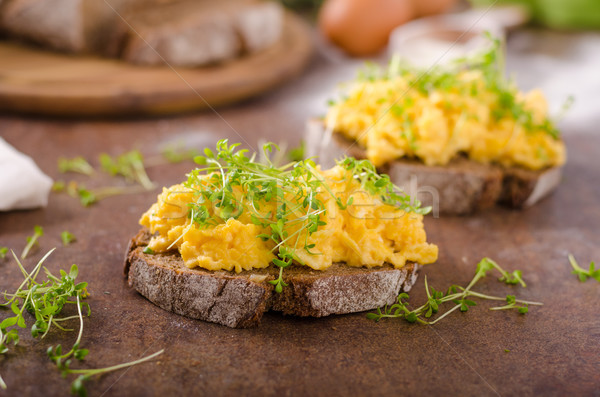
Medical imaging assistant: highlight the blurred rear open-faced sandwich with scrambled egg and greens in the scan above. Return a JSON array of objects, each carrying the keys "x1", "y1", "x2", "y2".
[{"x1": 306, "y1": 41, "x2": 566, "y2": 214}]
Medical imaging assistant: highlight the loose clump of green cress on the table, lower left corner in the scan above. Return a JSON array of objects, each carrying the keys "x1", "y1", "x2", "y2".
[{"x1": 0, "y1": 249, "x2": 163, "y2": 396}]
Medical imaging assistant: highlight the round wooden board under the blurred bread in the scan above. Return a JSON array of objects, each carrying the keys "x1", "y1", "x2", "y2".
[{"x1": 0, "y1": 13, "x2": 312, "y2": 116}]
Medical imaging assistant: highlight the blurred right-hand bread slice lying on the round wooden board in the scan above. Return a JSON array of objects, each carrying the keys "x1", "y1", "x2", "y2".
[{"x1": 122, "y1": 0, "x2": 283, "y2": 66}]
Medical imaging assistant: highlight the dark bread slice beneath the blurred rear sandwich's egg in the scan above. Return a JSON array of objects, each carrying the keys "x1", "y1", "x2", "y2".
[{"x1": 305, "y1": 119, "x2": 562, "y2": 216}]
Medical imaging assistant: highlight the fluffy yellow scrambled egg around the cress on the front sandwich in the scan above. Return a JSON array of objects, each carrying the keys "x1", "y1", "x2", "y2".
[{"x1": 140, "y1": 166, "x2": 438, "y2": 272}]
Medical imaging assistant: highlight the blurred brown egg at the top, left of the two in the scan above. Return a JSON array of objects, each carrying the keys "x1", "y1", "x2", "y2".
[{"x1": 319, "y1": 0, "x2": 418, "y2": 56}]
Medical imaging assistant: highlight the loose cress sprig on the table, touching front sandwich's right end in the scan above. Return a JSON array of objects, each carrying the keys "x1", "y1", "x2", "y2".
[{"x1": 367, "y1": 258, "x2": 542, "y2": 325}]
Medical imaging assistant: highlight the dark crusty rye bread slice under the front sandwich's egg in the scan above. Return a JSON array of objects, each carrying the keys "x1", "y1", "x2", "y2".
[{"x1": 125, "y1": 229, "x2": 419, "y2": 328}]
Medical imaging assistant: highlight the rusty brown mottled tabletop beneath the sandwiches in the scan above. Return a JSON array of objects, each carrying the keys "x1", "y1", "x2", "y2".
[{"x1": 0, "y1": 45, "x2": 600, "y2": 396}]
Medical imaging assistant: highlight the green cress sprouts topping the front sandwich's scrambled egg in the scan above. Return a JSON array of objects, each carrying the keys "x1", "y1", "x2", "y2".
[{"x1": 184, "y1": 140, "x2": 428, "y2": 292}]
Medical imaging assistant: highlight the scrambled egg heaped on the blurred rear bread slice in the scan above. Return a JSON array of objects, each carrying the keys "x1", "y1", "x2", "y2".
[{"x1": 325, "y1": 70, "x2": 566, "y2": 170}]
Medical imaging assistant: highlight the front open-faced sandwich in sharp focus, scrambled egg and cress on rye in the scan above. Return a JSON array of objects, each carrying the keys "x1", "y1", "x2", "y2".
[{"x1": 125, "y1": 141, "x2": 437, "y2": 327}]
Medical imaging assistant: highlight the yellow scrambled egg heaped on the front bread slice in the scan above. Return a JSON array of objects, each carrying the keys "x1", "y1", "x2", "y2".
[{"x1": 140, "y1": 161, "x2": 438, "y2": 272}]
